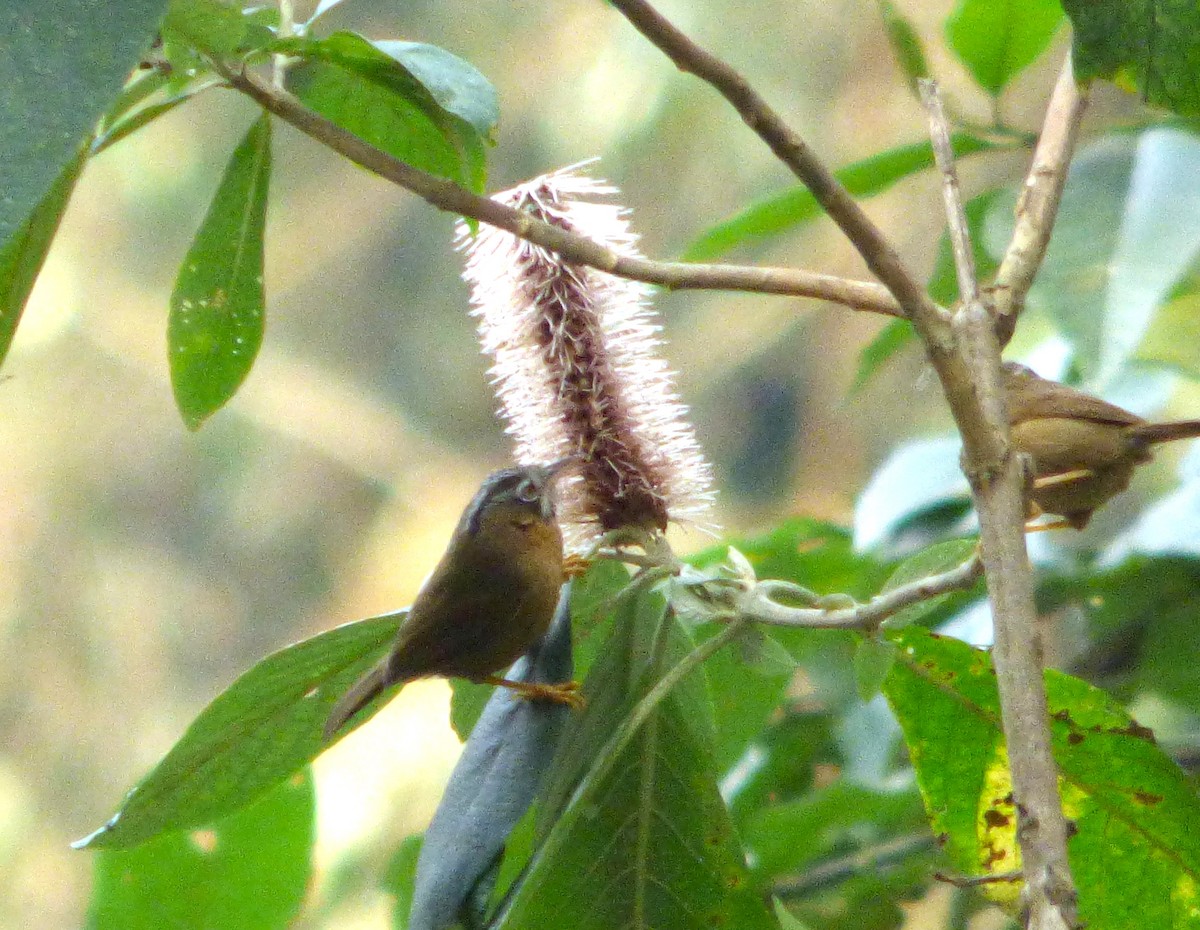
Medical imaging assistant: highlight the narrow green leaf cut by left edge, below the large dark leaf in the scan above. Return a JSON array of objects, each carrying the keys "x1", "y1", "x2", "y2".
[{"x1": 0, "y1": 147, "x2": 86, "y2": 364}]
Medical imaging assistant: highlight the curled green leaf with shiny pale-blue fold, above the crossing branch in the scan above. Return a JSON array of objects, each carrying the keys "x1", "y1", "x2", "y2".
[{"x1": 283, "y1": 32, "x2": 489, "y2": 191}]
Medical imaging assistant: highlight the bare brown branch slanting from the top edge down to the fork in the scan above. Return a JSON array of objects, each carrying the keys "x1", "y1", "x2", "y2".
[{"x1": 612, "y1": 0, "x2": 948, "y2": 336}]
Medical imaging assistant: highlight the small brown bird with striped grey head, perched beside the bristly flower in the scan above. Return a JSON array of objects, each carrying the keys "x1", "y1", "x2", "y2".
[{"x1": 324, "y1": 457, "x2": 582, "y2": 740}]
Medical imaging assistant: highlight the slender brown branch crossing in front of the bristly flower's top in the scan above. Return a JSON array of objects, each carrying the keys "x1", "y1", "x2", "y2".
[{"x1": 217, "y1": 66, "x2": 902, "y2": 317}]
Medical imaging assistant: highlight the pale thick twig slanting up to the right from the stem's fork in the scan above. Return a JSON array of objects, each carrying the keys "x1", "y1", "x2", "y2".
[{"x1": 994, "y1": 52, "x2": 1087, "y2": 346}]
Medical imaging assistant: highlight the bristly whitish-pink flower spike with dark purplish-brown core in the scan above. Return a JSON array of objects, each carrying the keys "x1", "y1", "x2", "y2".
[{"x1": 458, "y1": 167, "x2": 713, "y2": 547}]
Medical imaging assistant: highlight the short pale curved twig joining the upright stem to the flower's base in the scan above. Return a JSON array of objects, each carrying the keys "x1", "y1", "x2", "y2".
[{"x1": 737, "y1": 554, "x2": 983, "y2": 630}]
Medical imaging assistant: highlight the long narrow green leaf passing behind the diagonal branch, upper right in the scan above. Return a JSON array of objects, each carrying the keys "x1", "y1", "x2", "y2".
[{"x1": 683, "y1": 132, "x2": 1003, "y2": 262}]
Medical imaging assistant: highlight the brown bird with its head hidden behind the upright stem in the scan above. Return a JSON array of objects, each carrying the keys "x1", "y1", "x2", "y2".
[{"x1": 1003, "y1": 361, "x2": 1200, "y2": 529}]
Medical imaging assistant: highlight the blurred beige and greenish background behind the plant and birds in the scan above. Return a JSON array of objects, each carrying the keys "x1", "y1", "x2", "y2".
[{"x1": 0, "y1": 0, "x2": 1113, "y2": 928}]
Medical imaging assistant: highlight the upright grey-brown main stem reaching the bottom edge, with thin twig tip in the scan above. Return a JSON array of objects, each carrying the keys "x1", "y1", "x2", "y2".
[{"x1": 929, "y1": 86, "x2": 1078, "y2": 930}]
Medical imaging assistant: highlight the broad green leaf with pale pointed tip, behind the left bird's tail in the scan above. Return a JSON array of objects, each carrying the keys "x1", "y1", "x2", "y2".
[{"x1": 78, "y1": 611, "x2": 407, "y2": 847}]
